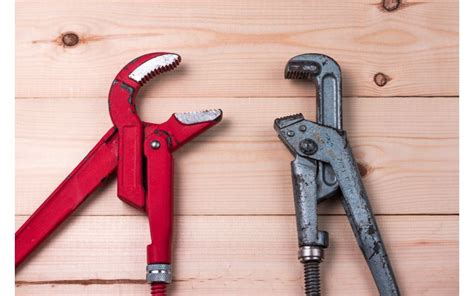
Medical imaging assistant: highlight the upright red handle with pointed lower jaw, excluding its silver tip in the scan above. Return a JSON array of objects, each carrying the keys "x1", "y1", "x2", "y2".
[{"x1": 143, "y1": 115, "x2": 220, "y2": 264}]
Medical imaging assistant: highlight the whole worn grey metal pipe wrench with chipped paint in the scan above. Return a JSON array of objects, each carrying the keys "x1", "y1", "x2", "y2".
[{"x1": 274, "y1": 54, "x2": 400, "y2": 296}]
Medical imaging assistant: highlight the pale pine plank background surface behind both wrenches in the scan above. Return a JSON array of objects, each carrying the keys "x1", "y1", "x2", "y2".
[{"x1": 16, "y1": 0, "x2": 459, "y2": 295}]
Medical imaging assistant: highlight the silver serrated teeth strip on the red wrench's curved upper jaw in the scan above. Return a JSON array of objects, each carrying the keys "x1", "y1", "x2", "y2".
[{"x1": 129, "y1": 53, "x2": 181, "y2": 86}]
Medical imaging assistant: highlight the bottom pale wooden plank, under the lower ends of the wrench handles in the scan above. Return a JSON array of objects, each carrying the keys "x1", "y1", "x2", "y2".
[{"x1": 16, "y1": 216, "x2": 458, "y2": 295}]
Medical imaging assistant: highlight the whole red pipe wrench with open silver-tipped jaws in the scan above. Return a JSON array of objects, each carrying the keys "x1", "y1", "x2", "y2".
[{"x1": 15, "y1": 52, "x2": 222, "y2": 295}]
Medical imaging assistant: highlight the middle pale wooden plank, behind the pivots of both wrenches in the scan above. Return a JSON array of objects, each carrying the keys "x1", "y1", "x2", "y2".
[{"x1": 16, "y1": 98, "x2": 458, "y2": 215}]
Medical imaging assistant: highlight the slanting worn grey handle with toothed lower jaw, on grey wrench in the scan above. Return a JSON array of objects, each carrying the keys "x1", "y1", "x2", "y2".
[{"x1": 275, "y1": 118, "x2": 400, "y2": 296}]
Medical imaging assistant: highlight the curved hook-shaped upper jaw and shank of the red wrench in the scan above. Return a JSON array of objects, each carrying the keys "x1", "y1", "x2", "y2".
[{"x1": 109, "y1": 52, "x2": 181, "y2": 208}]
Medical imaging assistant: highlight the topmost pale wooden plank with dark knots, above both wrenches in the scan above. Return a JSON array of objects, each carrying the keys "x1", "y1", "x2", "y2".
[{"x1": 16, "y1": 0, "x2": 458, "y2": 98}]
